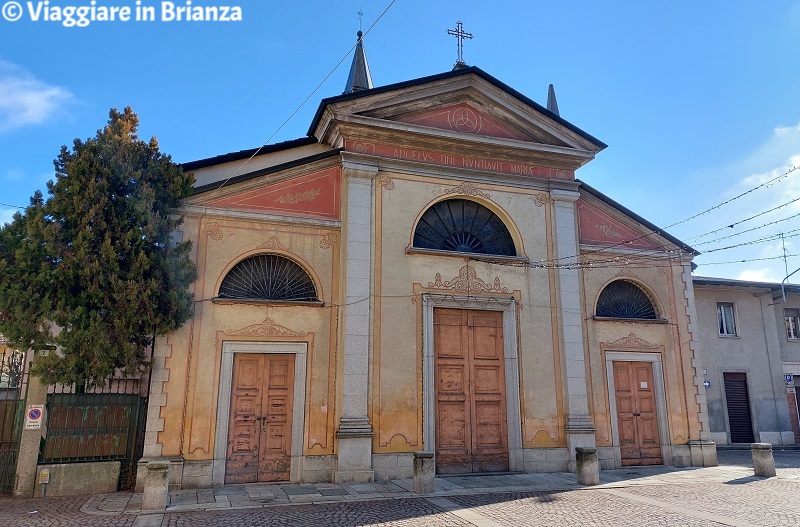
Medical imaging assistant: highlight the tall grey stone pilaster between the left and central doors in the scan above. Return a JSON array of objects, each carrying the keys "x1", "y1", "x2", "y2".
[{"x1": 333, "y1": 167, "x2": 377, "y2": 483}]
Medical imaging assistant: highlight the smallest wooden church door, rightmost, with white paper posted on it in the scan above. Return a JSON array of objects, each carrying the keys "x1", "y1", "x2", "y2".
[{"x1": 613, "y1": 361, "x2": 662, "y2": 466}]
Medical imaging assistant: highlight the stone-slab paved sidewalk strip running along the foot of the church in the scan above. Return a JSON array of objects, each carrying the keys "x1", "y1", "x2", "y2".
[{"x1": 81, "y1": 466, "x2": 800, "y2": 515}]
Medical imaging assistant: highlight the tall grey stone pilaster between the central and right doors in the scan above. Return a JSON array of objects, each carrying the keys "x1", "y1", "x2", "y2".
[{"x1": 550, "y1": 189, "x2": 595, "y2": 472}]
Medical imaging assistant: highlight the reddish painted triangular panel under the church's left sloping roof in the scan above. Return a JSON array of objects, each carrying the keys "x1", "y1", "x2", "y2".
[{"x1": 208, "y1": 167, "x2": 341, "y2": 219}]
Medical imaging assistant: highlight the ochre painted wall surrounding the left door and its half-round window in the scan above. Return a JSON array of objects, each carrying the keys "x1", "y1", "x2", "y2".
[{"x1": 158, "y1": 210, "x2": 340, "y2": 460}]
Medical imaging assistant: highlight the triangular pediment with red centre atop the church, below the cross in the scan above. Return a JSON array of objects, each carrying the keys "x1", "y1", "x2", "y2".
[{"x1": 310, "y1": 68, "x2": 606, "y2": 163}]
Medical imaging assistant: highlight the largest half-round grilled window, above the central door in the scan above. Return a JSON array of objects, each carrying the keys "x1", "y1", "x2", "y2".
[{"x1": 414, "y1": 199, "x2": 517, "y2": 256}]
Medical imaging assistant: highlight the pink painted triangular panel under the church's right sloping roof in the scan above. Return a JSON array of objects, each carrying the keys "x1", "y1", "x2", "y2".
[{"x1": 577, "y1": 199, "x2": 662, "y2": 249}]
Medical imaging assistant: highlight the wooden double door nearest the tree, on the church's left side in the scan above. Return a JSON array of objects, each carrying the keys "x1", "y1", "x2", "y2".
[{"x1": 225, "y1": 353, "x2": 294, "y2": 484}]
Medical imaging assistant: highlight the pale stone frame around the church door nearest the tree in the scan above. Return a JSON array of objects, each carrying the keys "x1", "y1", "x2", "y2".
[{"x1": 211, "y1": 341, "x2": 308, "y2": 486}]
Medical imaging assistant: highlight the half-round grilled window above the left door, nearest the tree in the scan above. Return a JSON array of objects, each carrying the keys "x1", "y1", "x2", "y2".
[{"x1": 219, "y1": 254, "x2": 319, "y2": 302}]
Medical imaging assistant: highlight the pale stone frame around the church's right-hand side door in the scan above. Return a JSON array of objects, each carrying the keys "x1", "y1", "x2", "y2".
[{"x1": 605, "y1": 351, "x2": 673, "y2": 467}]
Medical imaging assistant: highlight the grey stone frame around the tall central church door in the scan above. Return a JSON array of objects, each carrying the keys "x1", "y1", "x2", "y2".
[{"x1": 422, "y1": 293, "x2": 524, "y2": 472}]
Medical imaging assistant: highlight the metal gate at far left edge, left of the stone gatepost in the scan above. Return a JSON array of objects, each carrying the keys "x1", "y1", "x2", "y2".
[{"x1": 0, "y1": 348, "x2": 27, "y2": 495}]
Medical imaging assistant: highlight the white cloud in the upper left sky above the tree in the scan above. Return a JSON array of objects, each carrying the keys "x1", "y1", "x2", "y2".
[{"x1": 0, "y1": 60, "x2": 72, "y2": 132}]
